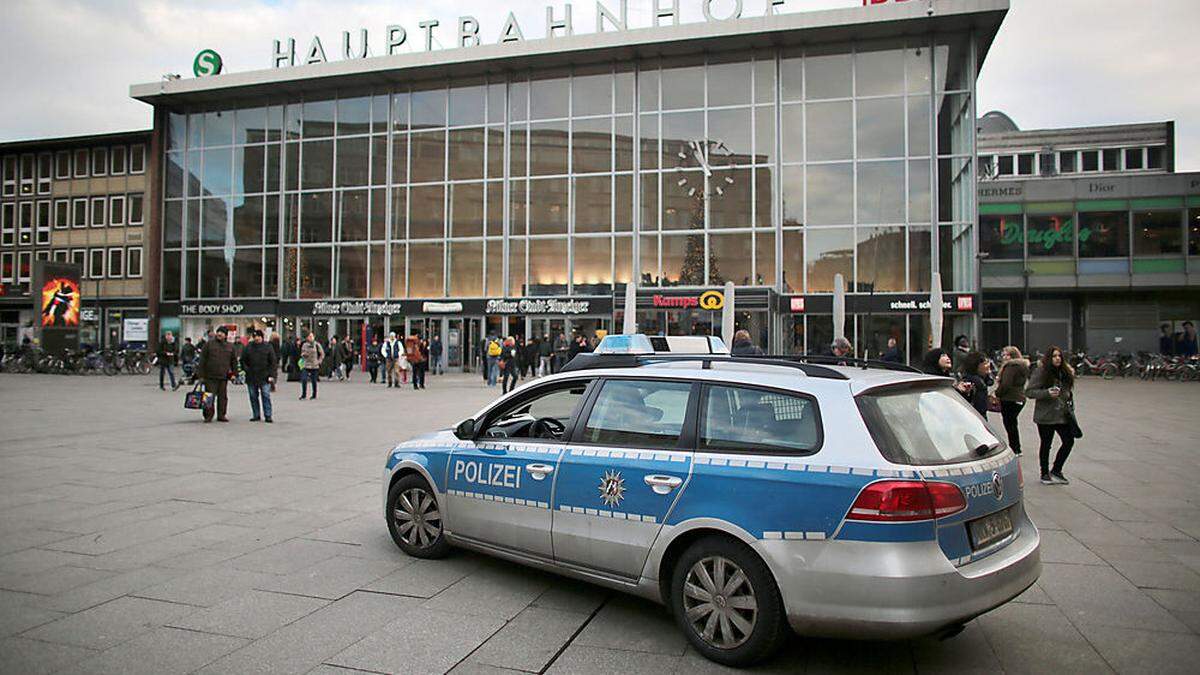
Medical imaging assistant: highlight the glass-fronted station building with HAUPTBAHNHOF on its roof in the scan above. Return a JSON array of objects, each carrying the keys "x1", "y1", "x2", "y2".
[{"x1": 121, "y1": 0, "x2": 1007, "y2": 368}]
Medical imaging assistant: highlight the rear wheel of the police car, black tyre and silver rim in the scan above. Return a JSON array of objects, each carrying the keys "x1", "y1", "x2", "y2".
[{"x1": 671, "y1": 537, "x2": 787, "y2": 667}]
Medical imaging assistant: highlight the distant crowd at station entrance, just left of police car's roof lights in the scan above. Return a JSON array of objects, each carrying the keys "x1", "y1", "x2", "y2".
[{"x1": 479, "y1": 333, "x2": 595, "y2": 394}]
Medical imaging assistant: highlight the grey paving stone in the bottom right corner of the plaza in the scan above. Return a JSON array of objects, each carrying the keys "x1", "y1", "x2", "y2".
[{"x1": 1079, "y1": 623, "x2": 1200, "y2": 675}]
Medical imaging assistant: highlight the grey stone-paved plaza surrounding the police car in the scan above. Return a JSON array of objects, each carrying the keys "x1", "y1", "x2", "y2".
[{"x1": 0, "y1": 375, "x2": 1200, "y2": 675}]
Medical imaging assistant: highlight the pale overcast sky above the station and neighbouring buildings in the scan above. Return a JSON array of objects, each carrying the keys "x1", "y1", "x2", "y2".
[{"x1": 0, "y1": 0, "x2": 1200, "y2": 171}]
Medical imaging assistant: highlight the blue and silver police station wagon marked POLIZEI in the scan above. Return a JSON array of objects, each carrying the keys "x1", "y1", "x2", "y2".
[{"x1": 383, "y1": 335, "x2": 1040, "y2": 665}]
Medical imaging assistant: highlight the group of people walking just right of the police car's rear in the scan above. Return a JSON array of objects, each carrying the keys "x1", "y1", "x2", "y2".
[{"x1": 922, "y1": 335, "x2": 1084, "y2": 485}]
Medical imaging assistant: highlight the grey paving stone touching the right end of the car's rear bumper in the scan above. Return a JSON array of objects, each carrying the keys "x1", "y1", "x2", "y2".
[{"x1": 1026, "y1": 563, "x2": 1188, "y2": 632}]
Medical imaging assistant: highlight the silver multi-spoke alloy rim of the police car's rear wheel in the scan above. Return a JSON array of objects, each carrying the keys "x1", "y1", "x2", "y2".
[{"x1": 683, "y1": 556, "x2": 758, "y2": 650}]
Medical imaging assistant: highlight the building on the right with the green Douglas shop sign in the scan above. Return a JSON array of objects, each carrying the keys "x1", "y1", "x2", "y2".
[{"x1": 978, "y1": 113, "x2": 1200, "y2": 353}]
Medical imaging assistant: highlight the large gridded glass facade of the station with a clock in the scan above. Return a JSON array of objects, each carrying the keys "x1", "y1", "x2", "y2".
[{"x1": 162, "y1": 36, "x2": 976, "y2": 309}]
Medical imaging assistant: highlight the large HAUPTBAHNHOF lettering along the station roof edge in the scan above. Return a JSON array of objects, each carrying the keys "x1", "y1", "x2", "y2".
[{"x1": 271, "y1": 0, "x2": 785, "y2": 68}]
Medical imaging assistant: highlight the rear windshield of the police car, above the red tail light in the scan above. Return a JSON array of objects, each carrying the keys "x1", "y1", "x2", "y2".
[{"x1": 858, "y1": 383, "x2": 1004, "y2": 465}]
